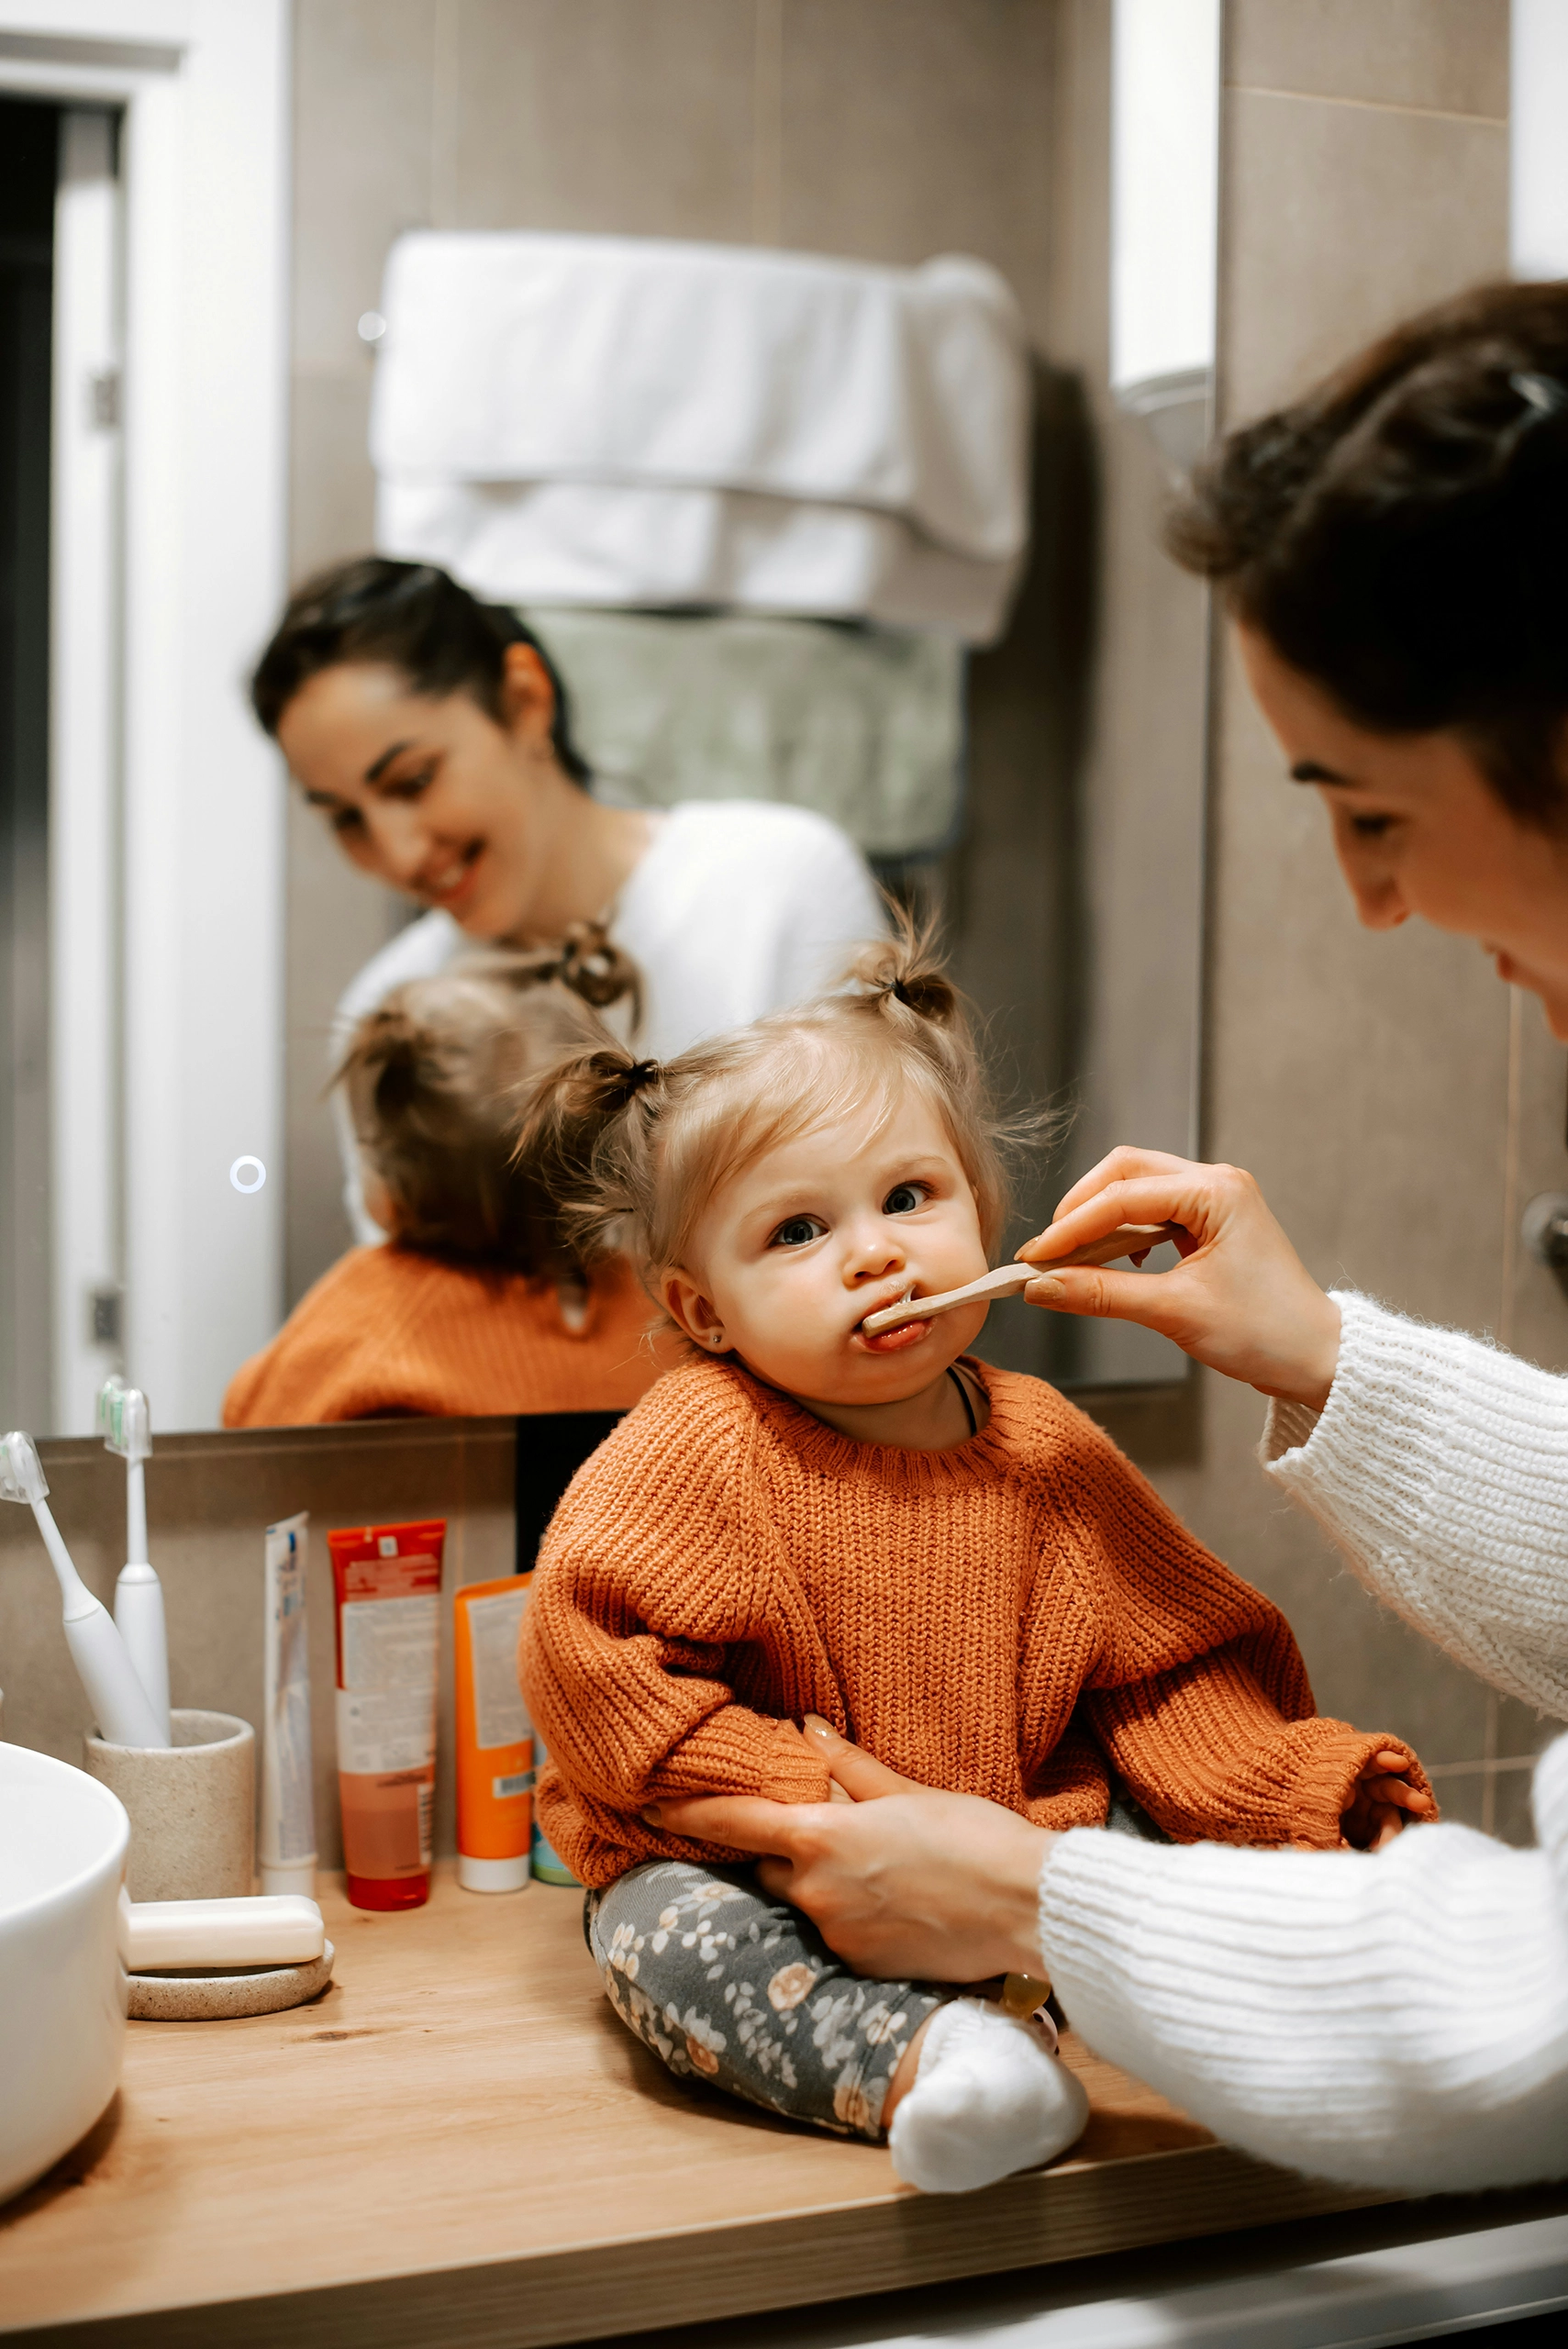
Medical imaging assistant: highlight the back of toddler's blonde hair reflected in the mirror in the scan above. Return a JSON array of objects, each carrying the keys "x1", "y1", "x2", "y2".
[{"x1": 333, "y1": 923, "x2": 636, "y2": 1280}]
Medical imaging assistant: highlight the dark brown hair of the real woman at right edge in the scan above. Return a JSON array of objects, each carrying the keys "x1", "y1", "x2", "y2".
[{"x1": 1167, "y1": 284, "x2": 1568, "y2": 827}]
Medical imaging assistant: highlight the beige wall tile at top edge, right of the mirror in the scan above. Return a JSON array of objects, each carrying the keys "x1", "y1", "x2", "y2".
[{"x1": 1225, "y1": 0, "x2": 1509, "y2": 120}]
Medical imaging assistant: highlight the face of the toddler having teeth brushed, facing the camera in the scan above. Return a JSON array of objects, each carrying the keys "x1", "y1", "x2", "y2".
[{"x1": 664, "y1": 1087, "x2": 986, "y2": 1405}]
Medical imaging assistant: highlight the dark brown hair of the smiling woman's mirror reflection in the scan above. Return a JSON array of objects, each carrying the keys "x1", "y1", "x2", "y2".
[{"x1": 251, "y1": 554, "x2": 589, "y2": 782}]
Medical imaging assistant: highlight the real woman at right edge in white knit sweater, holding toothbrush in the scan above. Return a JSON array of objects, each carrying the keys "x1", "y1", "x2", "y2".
[{"x1": 662, "y1": 284, "x2": 1568, "y2": 2191}]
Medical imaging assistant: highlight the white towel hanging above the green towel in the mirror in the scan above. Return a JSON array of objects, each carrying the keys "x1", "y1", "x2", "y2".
[{"x1": 371, "y1": 230, "x2": 1030, "y2": 643}]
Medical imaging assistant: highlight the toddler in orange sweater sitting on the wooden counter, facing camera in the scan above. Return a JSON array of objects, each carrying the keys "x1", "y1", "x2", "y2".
[{"x1": 521, "y1": 942, "x2": 1432, "y2": 2191}]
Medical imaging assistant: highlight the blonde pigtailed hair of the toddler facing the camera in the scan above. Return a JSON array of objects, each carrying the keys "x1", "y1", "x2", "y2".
[{"x1": 517, "y1": 921, "x2": 1042, "y2": 1283}]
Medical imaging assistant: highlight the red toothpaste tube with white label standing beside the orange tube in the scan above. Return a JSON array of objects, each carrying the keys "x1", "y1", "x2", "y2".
[{"x1": 327, "y1": 1518, "x2": 446, "y2": 1909}]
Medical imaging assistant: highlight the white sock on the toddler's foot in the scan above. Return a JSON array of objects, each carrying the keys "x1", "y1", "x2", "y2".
[{"x1": 887, "y1": 1999, "x2": 1089, "y2": 2194}]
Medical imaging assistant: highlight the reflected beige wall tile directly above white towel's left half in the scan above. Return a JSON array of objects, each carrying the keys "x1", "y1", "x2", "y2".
[{"x1": 437, "y1": 0, "x2": 756, "y2": 242}]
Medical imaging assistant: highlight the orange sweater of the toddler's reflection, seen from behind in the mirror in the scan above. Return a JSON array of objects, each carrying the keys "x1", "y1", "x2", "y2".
[{"x1": 223, "y1": 1245, "x2": 669, "y2": 1428}]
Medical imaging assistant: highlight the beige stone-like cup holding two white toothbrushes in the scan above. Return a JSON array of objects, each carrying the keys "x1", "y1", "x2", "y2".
[{"x1": 83, "y1": 1708, "x2": 256, "y2": 1900}]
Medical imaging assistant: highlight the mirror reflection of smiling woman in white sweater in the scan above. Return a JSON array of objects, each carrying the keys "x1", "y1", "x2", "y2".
[{"x1": 251, "y1": 557, "x2": 883, "y2": 1242}]
